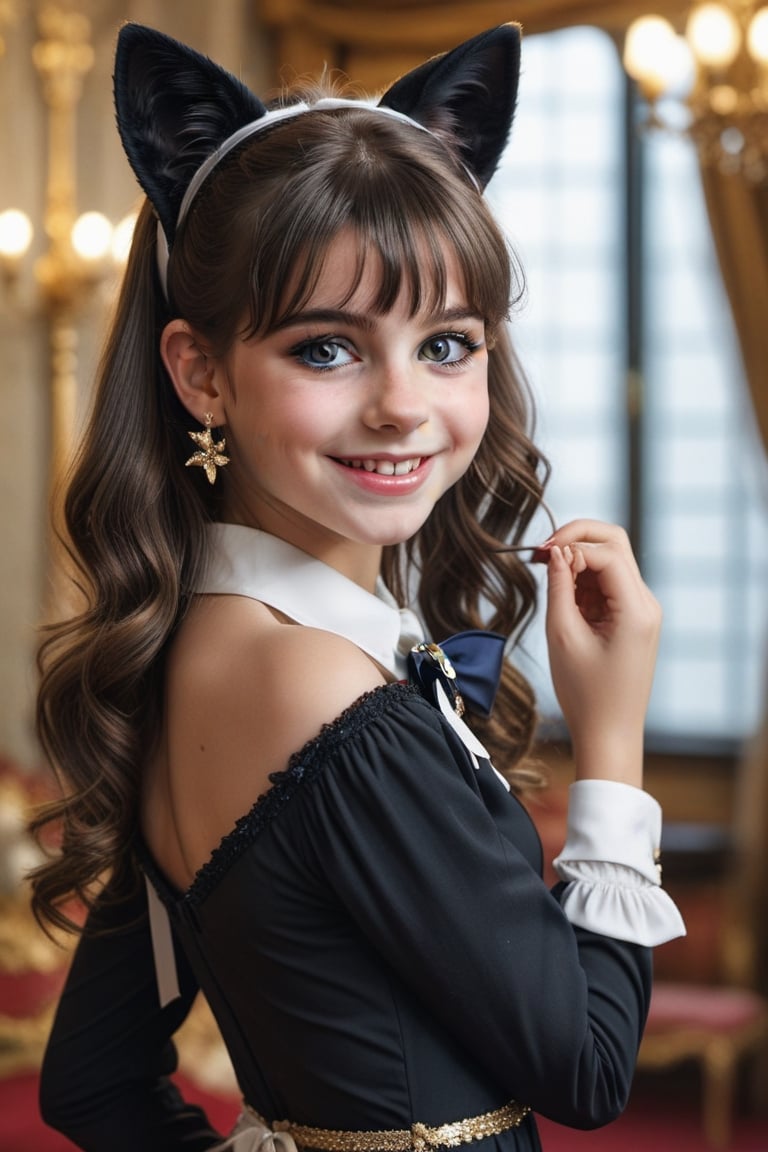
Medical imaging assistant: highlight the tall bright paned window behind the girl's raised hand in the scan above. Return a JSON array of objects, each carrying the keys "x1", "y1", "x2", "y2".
[{"x1": 488, "y1": 29, "x2": 768, "y2": 742}]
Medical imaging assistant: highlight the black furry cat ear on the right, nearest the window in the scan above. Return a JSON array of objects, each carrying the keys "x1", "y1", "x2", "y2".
[{"x1": 379, "y1": 24, "x2": 520, "y2": 188}]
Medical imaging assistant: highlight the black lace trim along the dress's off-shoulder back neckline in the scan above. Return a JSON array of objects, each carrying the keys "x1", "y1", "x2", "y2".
[{"x1": 184, "y1": 683, "x2": 421, "y2": 907}]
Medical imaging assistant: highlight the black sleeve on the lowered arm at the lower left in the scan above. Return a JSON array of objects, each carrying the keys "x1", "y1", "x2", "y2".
[{"x1": 40, "y1": 870, "x2": 221, "y2": 1152}]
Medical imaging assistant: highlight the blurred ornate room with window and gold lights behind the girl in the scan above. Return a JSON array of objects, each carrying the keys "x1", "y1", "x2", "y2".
[{"x1": 0, "y1": 0, "x2": 768, "y2": 1152}]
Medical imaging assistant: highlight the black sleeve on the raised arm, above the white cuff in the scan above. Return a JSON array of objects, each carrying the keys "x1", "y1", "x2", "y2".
[{"x1": 285, "y1": 686, "x2": 651, "y2": 1128}]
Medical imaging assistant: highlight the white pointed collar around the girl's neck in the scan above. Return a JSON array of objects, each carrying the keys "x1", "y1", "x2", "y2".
[{"x1": 197, "y1": 523, "x2": 424, "y2": 679}]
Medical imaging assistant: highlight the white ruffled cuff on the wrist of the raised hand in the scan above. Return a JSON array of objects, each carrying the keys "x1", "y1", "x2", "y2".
[{"x1": 554, "y1": 780, "x2": 685, "y2": 947}]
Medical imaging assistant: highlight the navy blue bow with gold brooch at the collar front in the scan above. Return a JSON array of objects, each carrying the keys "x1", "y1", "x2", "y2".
[{"x1": 408, "y1": 628, "x2": 507, "y2": 717}]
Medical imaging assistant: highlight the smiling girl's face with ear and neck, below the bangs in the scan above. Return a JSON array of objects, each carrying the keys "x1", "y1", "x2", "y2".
[{"x1": 169, "y1": 225, "x2": 488, "y2": 580}]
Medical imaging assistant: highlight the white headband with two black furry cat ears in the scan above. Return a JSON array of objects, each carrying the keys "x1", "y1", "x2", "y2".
[{"x1": 114, "y1": 24, "x2": 520, "y2": 297}]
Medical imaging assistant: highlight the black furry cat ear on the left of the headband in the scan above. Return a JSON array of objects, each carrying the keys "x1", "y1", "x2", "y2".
[{"x1": 114, "y1": 24, "x2": 266, "y2": 243}]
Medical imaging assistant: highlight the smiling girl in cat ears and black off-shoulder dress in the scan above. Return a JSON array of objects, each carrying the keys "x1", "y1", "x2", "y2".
[{"x1": 35, "y1": 25, "x2": 682, "y2": 1152}]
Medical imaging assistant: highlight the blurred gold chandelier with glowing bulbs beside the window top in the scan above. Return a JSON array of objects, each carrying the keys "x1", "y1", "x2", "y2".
[{"x1": 624, "y1": 0, "x2": 768, "y2": 183}]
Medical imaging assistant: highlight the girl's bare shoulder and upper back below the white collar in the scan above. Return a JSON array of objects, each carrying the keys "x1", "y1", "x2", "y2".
[{"x1": 144, "y1": 596, "x2": 385, "y2": 882}]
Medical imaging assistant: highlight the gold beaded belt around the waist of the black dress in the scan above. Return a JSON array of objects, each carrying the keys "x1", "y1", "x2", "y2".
[{"x1": 242, "y1": 1100, "x2": 531, "y2": 1152}]
